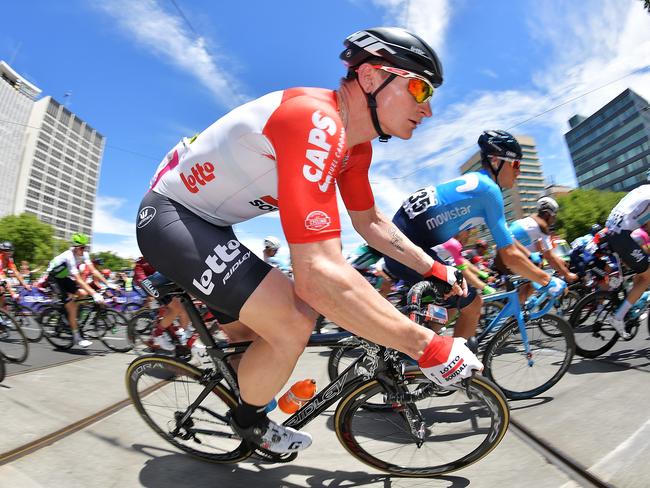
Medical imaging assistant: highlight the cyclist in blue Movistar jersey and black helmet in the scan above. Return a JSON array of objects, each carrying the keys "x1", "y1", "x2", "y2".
[{"x1": 384, "y1": 130, "x2": 566, "y2": 337}]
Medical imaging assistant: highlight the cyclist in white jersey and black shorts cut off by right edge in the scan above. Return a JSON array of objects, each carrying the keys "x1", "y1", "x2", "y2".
[{"x1": 606, "y1": 185, "x2": 650, "y2": 339}]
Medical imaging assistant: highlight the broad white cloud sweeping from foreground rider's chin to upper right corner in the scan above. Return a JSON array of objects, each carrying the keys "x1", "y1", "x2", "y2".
[{"x1": 364, "y1": 0, "x2": 650, "y2": 198}]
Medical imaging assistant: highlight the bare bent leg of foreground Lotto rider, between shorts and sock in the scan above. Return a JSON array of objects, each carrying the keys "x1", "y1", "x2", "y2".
[{"x1": 238, "y1": 269, "x2": 317, "y2": 405}]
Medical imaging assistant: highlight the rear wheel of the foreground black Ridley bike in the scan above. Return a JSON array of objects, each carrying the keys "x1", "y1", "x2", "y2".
[{"x1": 126, "y1": 355, "x2": 253, "y2": 463}]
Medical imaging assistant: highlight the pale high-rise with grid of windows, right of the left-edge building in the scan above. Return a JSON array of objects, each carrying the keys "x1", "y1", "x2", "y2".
[{"x1": 14, "y1": 96, "x2": 105, "y2": 239}]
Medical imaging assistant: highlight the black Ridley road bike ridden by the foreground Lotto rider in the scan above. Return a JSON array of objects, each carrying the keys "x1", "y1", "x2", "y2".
[{"x1": 126, "y1": 282, "x2": 509, "y2": 477}]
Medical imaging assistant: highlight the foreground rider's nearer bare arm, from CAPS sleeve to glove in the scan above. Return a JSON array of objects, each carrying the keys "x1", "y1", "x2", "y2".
[{"x1": 289, "y1": 239, "x2": 433, "y2": 358}]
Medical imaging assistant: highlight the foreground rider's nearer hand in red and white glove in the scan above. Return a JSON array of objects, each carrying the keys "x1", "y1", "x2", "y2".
[{"x1": 418, "y1": 336, "x2": 483, "y2": 386}]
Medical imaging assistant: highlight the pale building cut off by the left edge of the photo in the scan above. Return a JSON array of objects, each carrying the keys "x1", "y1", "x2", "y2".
[{"x1": 0, "y1": 61, "x2": 41, "y2": 217}]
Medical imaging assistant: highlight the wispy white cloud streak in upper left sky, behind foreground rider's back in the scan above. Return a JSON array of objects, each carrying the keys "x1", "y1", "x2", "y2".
[{"x1": 96, "y1": 0, "x2": 247, "y2": 108}]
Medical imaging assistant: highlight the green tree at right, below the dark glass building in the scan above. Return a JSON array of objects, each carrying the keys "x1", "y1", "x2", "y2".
[{"x1": 555, "y1": 190, "x2": 626, "y2": 242}]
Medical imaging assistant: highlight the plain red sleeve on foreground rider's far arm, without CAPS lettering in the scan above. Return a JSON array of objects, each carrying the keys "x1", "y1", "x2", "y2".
[{"x1": 337, "y1": 142, "x2": 375, "y2": 211}]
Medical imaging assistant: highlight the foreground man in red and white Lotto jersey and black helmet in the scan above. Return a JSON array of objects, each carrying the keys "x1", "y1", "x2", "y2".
[{"x1": 137, "y1": 28, "x2": 482, "y2": 452}]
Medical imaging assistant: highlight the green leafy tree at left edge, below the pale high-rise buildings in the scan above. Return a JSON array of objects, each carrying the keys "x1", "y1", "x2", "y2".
[{"x1": 0, "y1": 213, "x2": 56, "y2": 267}]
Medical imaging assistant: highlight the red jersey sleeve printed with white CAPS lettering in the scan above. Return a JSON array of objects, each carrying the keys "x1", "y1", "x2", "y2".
[{"x1": 264, "y1": 90, "x2": 347, "y2": 244}]
